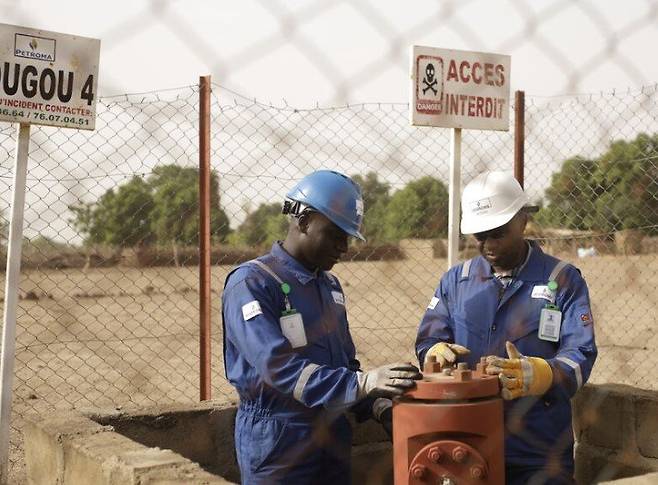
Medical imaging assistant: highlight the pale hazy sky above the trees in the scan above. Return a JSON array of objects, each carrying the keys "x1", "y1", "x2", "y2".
[{"x1": 0, "y1": 0, "x2": 658, "y2": 241}]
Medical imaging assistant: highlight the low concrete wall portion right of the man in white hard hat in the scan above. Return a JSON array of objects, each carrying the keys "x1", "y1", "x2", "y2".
[{"x1": 574, "y1": 384, "x2": 658, "y2": 484}]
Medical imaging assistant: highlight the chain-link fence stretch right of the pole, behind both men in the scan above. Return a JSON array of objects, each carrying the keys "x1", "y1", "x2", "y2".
[{"x1": 213, "y1": 81, "x2": 658, "y2": 388}]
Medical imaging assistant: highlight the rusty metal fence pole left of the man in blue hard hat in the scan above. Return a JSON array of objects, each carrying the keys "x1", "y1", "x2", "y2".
[{"x1": 199, "y1": 76, "x2": 210, "y2": 401}]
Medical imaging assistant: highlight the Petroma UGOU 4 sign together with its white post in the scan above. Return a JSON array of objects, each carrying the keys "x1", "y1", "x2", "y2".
[{"x1": 0, "y1": 24, "x2": 100, "y2": 485}]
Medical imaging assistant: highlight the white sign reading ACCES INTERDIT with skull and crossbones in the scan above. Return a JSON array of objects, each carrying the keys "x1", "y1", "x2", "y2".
[{"x1": 409, "y1": 46, "x2": 511, "y2": 130}]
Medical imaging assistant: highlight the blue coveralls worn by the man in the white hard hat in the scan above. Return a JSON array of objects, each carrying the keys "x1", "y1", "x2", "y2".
[{"x1": 416, "y1": 243, "x2": 597, "y2": 484}]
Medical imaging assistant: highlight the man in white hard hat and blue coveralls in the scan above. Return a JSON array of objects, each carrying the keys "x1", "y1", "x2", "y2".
[{"x1": 416, "y1": 171, "x2": 597, "y2": 485}]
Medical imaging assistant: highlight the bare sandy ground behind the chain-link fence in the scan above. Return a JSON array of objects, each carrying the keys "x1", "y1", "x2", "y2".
[{"x1": 2, "y1": 242, "x2": 658, "y2": 483}]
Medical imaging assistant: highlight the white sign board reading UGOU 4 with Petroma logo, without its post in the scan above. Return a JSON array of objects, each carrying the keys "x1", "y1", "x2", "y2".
[{"x1": 0, "y1": 24, "x2": 101, "y2": 130}]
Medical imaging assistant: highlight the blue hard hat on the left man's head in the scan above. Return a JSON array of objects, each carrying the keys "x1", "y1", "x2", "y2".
[{"x1": 286, "y1": 170, "x2": 366, "y2": 241}]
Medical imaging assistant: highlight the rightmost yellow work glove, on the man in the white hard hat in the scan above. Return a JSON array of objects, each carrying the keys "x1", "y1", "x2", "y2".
[{"x1": 487, "y1": 342, "x2": 553, "y2": 400}]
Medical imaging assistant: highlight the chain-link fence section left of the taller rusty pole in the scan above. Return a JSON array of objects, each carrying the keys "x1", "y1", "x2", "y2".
[{"x1": 0, "y1": 87, "x2": 210, "y2": 480}]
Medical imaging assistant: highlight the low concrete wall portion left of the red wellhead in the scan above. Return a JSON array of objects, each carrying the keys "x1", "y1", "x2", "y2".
[{"x1": 24, "y1": 401, "x2": 393, "y2": 485}]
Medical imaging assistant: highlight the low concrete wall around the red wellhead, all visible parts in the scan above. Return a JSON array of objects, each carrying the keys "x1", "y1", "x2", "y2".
[{"x1": 24, "y1": 385, "x2": 658, "y2": 485}]
